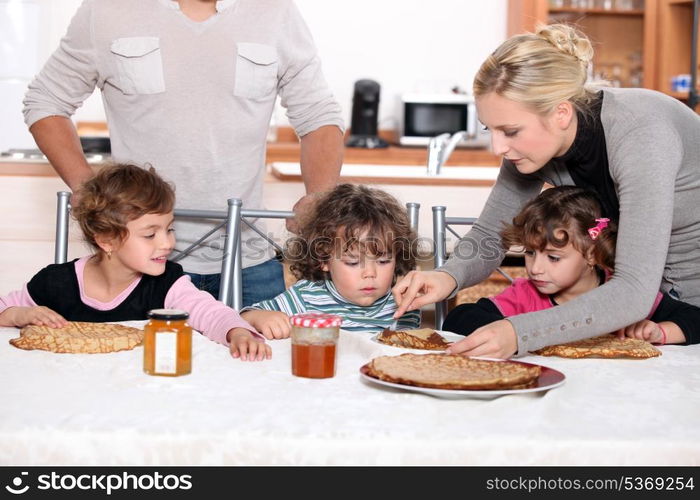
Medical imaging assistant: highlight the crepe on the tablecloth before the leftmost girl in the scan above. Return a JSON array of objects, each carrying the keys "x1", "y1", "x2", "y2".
[{"x1": 10, "y1": 321, "x2": 143, "y2": 354}]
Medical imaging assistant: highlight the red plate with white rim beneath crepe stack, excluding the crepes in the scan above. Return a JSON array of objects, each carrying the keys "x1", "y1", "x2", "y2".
[{"x1": 360, "y1": 360, "x2": 566, "y2": 399}]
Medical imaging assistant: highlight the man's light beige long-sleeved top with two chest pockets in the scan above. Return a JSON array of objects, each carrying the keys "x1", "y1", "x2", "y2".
[{"x1": 24, "y1": 0, "x2": 343, "y2": 273}]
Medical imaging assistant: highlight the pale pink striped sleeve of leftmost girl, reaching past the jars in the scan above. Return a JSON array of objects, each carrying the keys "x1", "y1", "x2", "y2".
[{"x1": 164, "y1": 276, "x2": 265, "y2": 346}]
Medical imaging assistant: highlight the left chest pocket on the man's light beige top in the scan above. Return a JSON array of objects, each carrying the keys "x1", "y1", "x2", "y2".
[{"x1": 110, "y1": 36, "x2": 165, "y2": 94}]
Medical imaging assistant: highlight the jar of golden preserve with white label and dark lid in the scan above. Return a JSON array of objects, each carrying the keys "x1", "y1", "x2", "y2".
[{"x1": 143, "y1": 309, "x2": 192, "y2": 377}]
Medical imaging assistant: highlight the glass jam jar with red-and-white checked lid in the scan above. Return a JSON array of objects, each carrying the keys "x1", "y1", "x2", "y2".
[{"x1": 289, "y1": 313, "x2": 343, "y2": 378}]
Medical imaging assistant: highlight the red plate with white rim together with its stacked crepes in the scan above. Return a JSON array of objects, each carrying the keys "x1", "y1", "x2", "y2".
[{"x1": 360, "y1": 353, "x2": 566, "y2": 399}]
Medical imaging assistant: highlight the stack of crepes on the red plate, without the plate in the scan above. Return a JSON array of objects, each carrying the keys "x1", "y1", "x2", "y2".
[{"x1": 367, "y1": 354, "x2": 540, "y2": 390}]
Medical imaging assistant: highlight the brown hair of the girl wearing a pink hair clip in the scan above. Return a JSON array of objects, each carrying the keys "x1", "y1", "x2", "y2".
[{"x1": 501, "y1": 186, "x2": 617, "y2": 271}]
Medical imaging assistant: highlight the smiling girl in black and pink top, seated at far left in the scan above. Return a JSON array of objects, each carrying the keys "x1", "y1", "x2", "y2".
[{"x1": 0, "y1": 165, "x2": 272, "y2": 361}]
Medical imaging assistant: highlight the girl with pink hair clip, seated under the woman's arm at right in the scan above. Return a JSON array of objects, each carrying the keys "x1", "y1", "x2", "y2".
[{"x1": 443, "y1": 186, "x2": 700, "y2": 345}]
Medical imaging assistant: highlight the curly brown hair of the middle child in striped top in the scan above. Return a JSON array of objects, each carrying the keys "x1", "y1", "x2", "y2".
[{"x1": 285, "y1": 184, "x2": 418, "y2": 281}]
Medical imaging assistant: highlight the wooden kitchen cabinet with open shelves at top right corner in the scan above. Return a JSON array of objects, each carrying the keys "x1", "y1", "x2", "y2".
[{"x1": 508, "y1": 0, "x2": 697, "y2": 105}]
